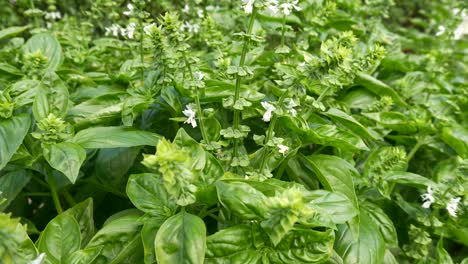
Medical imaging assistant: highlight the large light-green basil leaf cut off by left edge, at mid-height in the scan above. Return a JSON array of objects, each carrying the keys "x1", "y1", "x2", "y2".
[{"x1": 0, "y1": 114, "x2": 31, "y2": 170}]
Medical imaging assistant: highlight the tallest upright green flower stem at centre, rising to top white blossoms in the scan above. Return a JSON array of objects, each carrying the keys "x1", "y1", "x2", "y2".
[{"x1": 233, "y1": 7, "x2": 257, "y2": 158}]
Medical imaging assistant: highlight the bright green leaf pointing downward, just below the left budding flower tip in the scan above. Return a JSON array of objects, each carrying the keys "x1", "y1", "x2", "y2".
[{"x1": 44, "y1": 142, "x2": 86, "y2": 183}]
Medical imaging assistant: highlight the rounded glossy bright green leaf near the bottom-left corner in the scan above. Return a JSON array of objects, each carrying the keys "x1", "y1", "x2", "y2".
[{"x1": 37, "y1": 214, "x2": 81, "y2": 263}]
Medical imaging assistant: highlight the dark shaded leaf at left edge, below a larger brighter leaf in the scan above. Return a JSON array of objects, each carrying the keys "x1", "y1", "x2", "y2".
[{"x1": 0, "y1": 170, "x2": 31, "y2": 211}]
